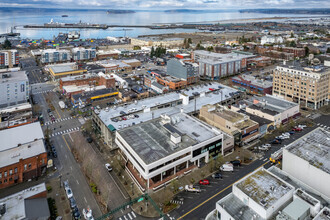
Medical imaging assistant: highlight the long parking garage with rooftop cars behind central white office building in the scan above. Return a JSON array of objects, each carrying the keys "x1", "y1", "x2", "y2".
[{"x1": 92, "y1": 82, "x2": 244, "y2": 147}]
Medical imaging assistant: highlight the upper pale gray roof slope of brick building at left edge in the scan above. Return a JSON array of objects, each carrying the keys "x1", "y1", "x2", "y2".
[{"x1": 0, "y1": 122, "x2": 44, "y2": 152}]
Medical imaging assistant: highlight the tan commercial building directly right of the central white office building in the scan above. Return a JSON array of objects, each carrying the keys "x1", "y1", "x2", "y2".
[{"x1": 199, "y1": 105, "x2": 260, "y2": 145}]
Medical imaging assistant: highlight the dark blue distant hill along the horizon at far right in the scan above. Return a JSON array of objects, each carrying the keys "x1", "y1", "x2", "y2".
[{"x1": 239, "y1": 8, "x2": 330, "y2": 14}]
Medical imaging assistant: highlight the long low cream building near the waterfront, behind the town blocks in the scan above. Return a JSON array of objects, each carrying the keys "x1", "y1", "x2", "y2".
[{"x1": 130, "y1": 37, "x2": 184, "y2": 48}]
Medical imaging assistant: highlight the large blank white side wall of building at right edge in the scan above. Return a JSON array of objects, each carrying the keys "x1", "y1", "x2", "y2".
[{"x1": 282, "y1": 149, "x2": 330, "y2": 197}]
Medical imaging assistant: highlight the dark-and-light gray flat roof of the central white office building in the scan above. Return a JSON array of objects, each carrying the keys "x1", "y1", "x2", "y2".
[{"x1": 118, "y1": 113, "x2": 220, "y2": 164}]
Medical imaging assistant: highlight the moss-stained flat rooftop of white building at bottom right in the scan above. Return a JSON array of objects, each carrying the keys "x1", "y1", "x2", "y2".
[{"x1": 236, "y1": 168, "x2": 294, "y2": 209}]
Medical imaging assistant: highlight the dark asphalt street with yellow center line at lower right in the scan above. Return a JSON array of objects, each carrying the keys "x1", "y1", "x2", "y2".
[{"x1": 169, "y1": 116, "x2": 330, "y2": 220}]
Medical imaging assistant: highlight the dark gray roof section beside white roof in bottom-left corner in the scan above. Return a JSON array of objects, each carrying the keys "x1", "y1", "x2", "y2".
[{"x1": 24, "y1": 198, "x2": 50, "y2": 220}]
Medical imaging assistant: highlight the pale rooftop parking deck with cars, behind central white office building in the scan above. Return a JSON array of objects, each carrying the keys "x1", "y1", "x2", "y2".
[{"x1": 98, "y1": 82, "x2": 238, "y2": 130}]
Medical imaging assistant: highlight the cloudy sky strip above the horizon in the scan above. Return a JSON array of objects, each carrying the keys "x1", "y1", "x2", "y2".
[{"x1": 0, "y1": 0, "x2": 330, "y2": 10}]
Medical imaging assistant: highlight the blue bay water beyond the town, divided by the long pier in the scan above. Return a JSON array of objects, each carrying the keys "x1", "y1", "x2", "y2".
[{"x1": 0, "y1": 9, "x2": 320, "y2": 39}]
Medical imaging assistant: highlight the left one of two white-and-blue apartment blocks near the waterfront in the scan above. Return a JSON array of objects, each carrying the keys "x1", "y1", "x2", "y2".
[{"x1": 41, "y1": 49, "x2": 71, "y2": 63}]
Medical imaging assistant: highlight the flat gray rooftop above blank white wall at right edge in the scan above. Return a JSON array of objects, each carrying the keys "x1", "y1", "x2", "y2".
[{"x1": 285, "y1": 127, "x2": 330, "y2": 174}]
